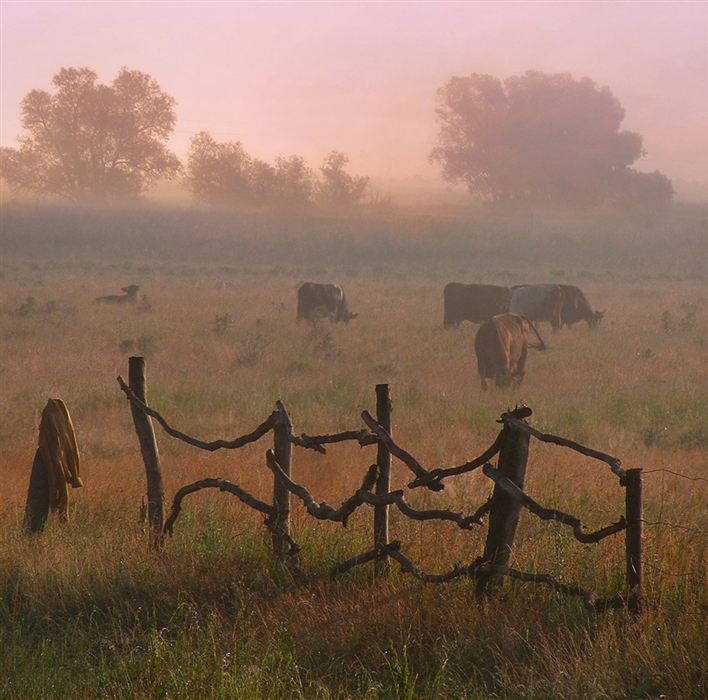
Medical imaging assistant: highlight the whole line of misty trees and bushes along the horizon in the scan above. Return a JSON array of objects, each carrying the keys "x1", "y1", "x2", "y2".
[{"x1": 0, "y1": 68, "x2": 674, "y2": 209}]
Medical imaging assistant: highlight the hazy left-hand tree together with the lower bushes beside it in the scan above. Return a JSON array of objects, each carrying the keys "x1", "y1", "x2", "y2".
[{"x1": 0, "y1": 68, "x2": 369, "y2": 208}]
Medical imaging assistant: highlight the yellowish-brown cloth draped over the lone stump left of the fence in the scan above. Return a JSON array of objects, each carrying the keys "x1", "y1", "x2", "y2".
[{"x1": 39, "y1": 399, "x2": 83, "y2": 520}]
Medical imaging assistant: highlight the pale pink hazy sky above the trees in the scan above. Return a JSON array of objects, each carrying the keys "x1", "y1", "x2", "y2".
[{"x1": 0, "y1": 0, "x2": 708, "y2": 194}]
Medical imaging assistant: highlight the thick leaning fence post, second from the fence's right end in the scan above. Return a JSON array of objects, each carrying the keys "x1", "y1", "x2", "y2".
[{"x1": 477, "y1": 407, "x2": 531, "y2": 595}]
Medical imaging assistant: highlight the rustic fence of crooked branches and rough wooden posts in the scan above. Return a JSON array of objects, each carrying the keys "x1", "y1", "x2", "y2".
[{"x1": 118, "y1": 358, "x2": 643, "y2": 613}]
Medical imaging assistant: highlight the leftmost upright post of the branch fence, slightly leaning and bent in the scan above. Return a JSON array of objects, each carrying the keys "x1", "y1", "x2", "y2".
[{"x1": 128, "y1": 357, "x2": 165, "y2": 549}]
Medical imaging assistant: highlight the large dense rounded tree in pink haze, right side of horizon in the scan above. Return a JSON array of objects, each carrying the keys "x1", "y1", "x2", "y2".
[{"x1": 430, "y1": 71, "x2": 673, "y2": 211}]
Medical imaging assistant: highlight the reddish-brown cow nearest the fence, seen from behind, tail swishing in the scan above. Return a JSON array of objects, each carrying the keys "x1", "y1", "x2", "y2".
[{"x1": 474, "y1": 313, "x2": 546, "y2": 391}]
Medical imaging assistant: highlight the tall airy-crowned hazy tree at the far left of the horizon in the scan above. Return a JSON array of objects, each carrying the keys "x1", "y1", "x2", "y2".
[{"x1": 2, "y1": 68, "x2": 181, "y2": 202}]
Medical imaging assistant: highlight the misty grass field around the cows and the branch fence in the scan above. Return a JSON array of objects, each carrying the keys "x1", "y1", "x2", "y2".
[{"x1": 0, "y1": 200, "x2": 708, "y2": 699}]
